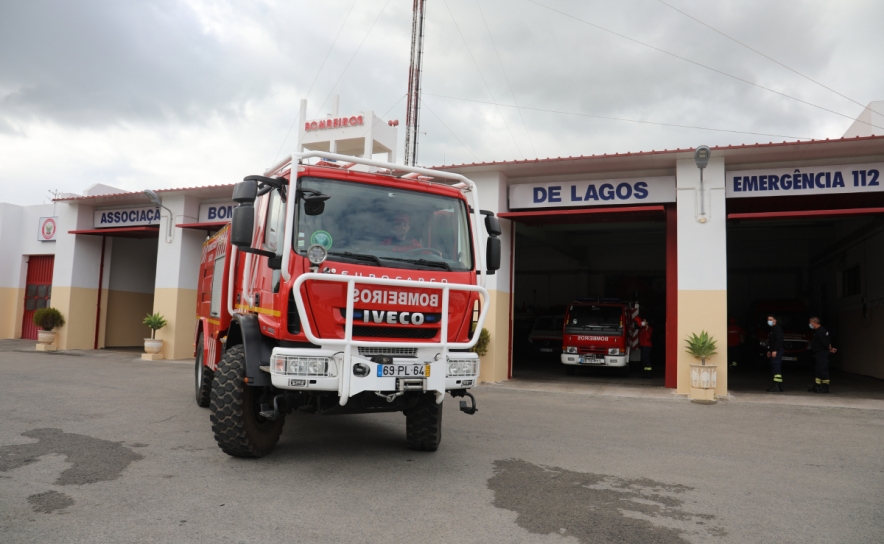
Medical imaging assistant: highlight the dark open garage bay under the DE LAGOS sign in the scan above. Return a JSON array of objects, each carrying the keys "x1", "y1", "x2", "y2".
[{"x1": 504, "y1": 210, "x2": 667, "y2": 385}]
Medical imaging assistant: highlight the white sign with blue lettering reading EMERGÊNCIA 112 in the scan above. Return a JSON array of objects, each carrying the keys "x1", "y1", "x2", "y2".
[{"x1": 726, "y1": 163, "x2": 884, "y2": 198}]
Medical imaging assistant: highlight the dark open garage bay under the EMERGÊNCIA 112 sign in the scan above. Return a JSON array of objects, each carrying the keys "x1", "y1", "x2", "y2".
[{"x1": 727, "y1": 195, "x2": 884, "y2": 394}]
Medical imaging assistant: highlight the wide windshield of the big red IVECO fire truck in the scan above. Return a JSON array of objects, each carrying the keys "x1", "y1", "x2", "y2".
[{"x1": 292, "y1": 177, "x2": 473, "y2": 271}]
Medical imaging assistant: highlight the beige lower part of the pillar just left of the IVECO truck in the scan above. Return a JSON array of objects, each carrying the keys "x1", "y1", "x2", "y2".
[{"x1": 153, "y1": 288, "x2": 197, "y2": 359}]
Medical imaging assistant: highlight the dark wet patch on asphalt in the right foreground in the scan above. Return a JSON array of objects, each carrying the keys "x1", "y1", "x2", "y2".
[{"x1": 488, "y1": 459, "x2": 727, "y2": 544}]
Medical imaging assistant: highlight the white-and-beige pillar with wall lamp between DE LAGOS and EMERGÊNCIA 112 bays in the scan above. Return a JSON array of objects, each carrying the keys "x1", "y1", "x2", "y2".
[{"x1": 676, "y1": 157, "x2": 727, "y2": 395}]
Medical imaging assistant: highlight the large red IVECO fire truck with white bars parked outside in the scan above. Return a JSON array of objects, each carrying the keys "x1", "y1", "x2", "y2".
[{"x1": 195, "y1": 152, "x2": 500, "y2": 457}]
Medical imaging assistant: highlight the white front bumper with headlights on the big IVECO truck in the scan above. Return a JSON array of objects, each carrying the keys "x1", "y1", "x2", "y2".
[{"x1": 270, "y1": 348, "x2": 479, "y2": 402}]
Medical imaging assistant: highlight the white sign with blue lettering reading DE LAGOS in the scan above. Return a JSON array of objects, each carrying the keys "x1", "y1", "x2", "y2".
[{"x1": 509, "y1": 176, "x2": 675, "y2": 210}]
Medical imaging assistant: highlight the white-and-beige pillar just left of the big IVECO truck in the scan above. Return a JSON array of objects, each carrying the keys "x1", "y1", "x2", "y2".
[{"x1": 153, "y1": 196, "x2": 206, "y2": 359}]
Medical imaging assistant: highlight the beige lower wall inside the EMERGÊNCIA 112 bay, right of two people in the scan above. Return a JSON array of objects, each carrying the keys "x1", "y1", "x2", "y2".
[{"x1": 836, "y1": 308, "x2": 884, "y2": 379}]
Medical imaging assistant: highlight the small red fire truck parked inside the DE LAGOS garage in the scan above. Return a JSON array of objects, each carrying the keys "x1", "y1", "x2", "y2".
[{"x1": 562, "y1": 299, "x2": 638, "y2": 374}]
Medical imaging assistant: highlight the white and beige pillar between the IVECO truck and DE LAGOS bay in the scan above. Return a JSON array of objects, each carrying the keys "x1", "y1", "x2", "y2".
[{"x1": 467, "y1": 172, "x2": 515, "y2": 382}]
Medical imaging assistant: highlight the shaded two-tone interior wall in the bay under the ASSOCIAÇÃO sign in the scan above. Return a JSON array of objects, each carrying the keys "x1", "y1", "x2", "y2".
[{"x1": 102, "y1": 238, "x2": 157, "y2": 347}]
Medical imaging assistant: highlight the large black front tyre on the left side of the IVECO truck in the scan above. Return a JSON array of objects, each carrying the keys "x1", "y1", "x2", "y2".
[{"x1": 211, "y1": 346, "x2": 285, "y2": 457}]
